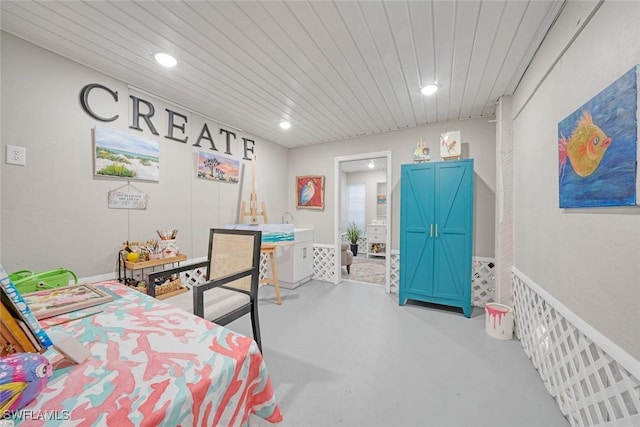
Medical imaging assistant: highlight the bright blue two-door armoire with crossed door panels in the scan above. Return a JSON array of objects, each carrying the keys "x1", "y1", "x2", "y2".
[{"x1": 399, "y1": 159, "x2": 474, "y2": 317}]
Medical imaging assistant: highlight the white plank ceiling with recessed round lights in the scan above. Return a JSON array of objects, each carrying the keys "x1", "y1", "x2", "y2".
[{"x1": 1, "y1": 0, "x2": 564, "y2": 147}]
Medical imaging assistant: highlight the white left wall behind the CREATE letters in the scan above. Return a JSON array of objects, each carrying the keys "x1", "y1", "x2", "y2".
[{"x1": 0, "y1": 33, "x2": 289, "y2": 277}]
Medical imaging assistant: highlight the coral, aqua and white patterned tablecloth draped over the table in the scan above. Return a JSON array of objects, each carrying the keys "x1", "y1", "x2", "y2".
[{"x1": 20, "y1": 281, "x2": 282, "y2": 427}]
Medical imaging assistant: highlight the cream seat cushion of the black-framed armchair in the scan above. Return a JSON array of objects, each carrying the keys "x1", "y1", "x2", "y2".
[{"x1": 164, "y1": 288, "x2": 250, "y2": 321}]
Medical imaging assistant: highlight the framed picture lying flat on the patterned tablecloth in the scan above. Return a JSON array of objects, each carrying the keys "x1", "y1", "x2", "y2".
[{"x1": 22, "y1": 284, "x2": 113, "y2": 319}]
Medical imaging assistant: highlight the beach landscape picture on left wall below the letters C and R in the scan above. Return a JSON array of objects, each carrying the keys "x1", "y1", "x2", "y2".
[{"x1": 93, "y1": 126, "x2": 160, "y2": 182}]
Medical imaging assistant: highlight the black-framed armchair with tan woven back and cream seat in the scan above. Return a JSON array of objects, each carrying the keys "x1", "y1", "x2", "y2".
[{"x1": 147, "y1": 228, "x2": 262, "y2": 351}]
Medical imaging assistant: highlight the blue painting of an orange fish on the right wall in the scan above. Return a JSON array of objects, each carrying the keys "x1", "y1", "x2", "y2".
[{"x1": 558, "y1": 66, "x2": 638, "y2": 208}]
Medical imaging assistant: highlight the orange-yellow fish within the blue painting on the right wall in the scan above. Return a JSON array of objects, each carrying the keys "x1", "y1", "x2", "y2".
[{"x1": 558, "y1": 111, "x2": 612, "y2": 177}]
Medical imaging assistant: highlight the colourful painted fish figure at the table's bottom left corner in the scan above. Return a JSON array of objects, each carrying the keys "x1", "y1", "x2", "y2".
[{"x1": 0, "y1": 353, "x2": 53, "y2": 414}]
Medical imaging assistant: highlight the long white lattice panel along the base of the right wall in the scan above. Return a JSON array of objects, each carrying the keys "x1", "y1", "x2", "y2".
[{"x1": 512, "y1": 272, "x2": 640, "y2": 427}]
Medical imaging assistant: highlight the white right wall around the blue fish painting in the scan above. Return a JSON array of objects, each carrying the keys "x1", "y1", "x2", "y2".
[{"x1": 513, "y1": 1, "x2": 640, "y2": 359}]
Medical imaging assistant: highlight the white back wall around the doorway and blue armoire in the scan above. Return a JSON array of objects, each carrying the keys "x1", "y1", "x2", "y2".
[{"x1": 289, "y1": 119, "x2": 496, "y2": 257}]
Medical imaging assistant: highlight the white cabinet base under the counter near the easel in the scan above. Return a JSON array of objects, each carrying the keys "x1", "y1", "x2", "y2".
[{"x1": 276, "y1": 228, "x2": 313, "y2": 289}]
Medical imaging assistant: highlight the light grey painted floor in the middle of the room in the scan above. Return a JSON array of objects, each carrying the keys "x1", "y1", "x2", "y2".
[{"x1": 228, "y1": 281, "x2": 569, "y2": 427}]
